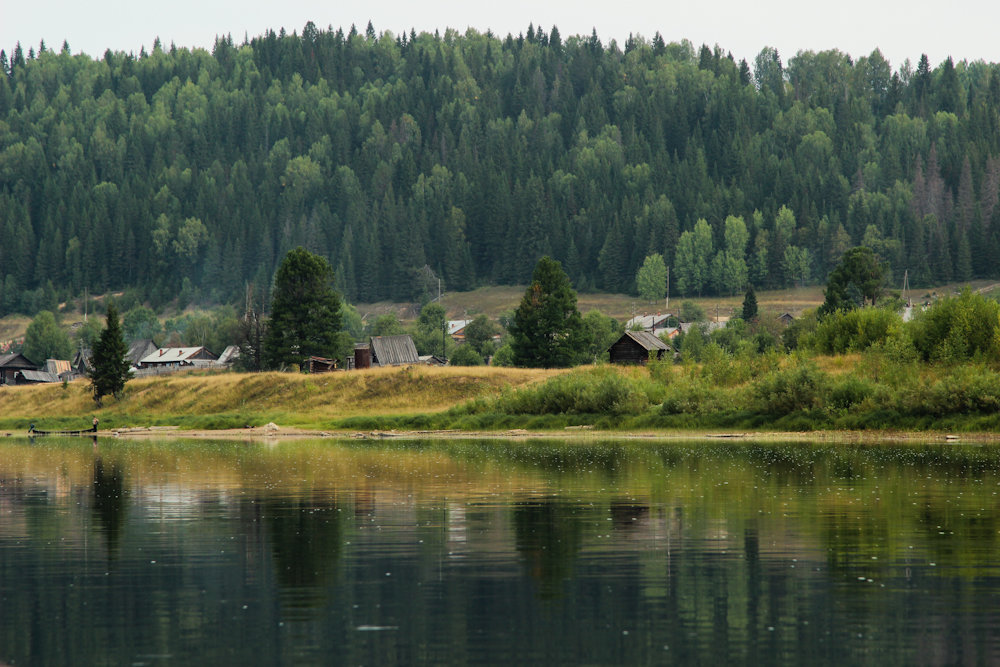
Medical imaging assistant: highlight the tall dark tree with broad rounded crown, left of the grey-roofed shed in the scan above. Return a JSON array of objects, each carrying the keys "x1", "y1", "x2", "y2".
[{"x1": 263, "y1": 247, "x2": 341, "y2": 368}]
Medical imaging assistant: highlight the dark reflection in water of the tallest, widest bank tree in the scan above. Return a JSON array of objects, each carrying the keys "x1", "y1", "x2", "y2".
[{"x1": 258, "y1": 495, "x2": 343, "y2": 610}]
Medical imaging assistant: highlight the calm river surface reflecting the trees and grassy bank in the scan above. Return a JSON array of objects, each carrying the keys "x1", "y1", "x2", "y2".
[{"x1": 0, "y1": 438, "x2": 1000, "y2": 665}]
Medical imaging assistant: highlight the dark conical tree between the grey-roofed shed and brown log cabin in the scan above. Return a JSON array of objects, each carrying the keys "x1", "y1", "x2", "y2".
[{"x1": 510, "y1": 257, "x2": 586, "y2": 368}]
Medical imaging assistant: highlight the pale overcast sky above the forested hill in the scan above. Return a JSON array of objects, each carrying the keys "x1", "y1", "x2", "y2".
[{"x1": 0, "y1": 0, "x2": 1000, "y2": 69}]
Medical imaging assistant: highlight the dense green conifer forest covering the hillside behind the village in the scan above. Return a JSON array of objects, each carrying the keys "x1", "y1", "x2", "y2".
[{"x1": 0, "y1": 23, "x2": 1000, "y2": 314}]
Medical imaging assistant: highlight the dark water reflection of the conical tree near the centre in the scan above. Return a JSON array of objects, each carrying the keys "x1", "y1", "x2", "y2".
[{"x1": 514, "y1": 498, "x2": 583, "y2": 598}]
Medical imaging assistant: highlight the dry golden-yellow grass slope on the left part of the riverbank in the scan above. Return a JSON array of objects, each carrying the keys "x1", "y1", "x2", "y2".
[{"x1": 0, "y1": 366, "x2": 560, "y2": 431}]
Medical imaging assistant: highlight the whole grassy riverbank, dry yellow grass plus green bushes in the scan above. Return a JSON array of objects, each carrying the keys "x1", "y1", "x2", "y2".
[{"x1": 0, "y1": 353, "x2": 1000, "y2": 433}]
